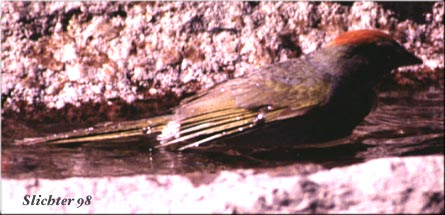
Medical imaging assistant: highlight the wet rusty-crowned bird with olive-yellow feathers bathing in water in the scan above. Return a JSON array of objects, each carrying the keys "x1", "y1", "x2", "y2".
[{"x1": 16, "y1": 29, "x2": 422, "y2": 151}]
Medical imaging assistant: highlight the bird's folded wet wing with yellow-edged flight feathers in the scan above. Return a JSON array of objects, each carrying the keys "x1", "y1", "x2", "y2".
[{"x1": 159, "y1": 58, "x2": 330, "y2": 150}]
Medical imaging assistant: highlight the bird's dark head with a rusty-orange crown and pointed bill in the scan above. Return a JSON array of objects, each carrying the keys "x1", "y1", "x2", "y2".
[{"x1": 316, "y1": 30, "x2": 422, "y2": 82}]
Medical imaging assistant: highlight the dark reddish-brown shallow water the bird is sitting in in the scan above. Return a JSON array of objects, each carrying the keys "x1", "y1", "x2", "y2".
[{"x1": 2, "y1": 86, "x2": 444, "y2": 178}]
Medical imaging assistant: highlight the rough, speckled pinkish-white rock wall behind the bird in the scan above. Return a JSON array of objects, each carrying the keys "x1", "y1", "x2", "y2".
[{"x1": 1, "y1": 2, "x2": 444, "y2": 115}]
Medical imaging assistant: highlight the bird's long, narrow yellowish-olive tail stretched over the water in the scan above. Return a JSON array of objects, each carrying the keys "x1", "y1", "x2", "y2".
[{"x1": 15, "y1": 115, "x2": 172, "y2": 145}]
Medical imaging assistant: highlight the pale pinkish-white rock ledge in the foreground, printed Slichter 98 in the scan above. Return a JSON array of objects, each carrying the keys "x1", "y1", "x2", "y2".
[{"x1": 2, "y1": 155, "x2": 444, "y2": 213}]
